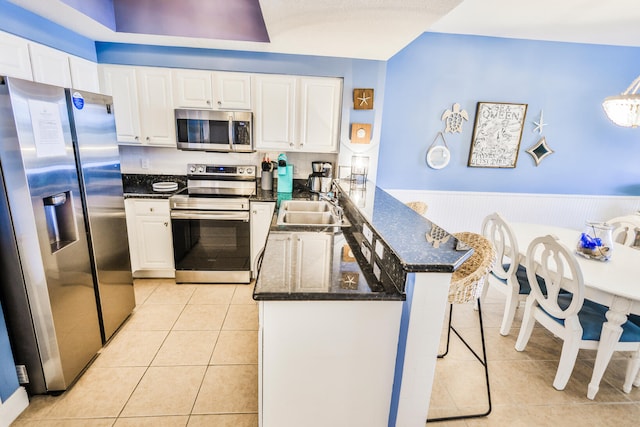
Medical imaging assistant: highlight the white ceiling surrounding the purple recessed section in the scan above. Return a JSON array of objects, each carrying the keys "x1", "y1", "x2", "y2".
[{"x1": 10, "y1": 0, "x2": 640, "y2": 60}]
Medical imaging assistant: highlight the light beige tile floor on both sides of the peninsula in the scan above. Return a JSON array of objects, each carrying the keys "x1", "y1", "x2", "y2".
[{"x1": 13, "y1": 279, "x2": 640, "y2": 427}]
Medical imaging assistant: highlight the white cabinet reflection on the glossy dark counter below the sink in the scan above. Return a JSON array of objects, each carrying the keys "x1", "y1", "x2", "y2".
[{"x1": 269, "y1": 232, "x2": 333, "y2": 292}]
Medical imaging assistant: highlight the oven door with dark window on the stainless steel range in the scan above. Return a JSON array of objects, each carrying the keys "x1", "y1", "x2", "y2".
[{"x1": 171, "y1": 210, "x2": 251, "y2": 283}]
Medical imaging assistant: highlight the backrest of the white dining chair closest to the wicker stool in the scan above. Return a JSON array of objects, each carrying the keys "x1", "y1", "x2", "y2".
[{"x1": 482, "y1": 212, "x2": 521, "y2": 280}]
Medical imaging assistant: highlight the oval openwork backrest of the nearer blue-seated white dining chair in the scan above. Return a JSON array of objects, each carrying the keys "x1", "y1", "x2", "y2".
[{"x1": 526, "y1": 235, "x2": 584, "y2": 321}]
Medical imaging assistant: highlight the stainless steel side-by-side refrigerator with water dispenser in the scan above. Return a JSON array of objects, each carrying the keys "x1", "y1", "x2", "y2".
[{"x1": 0, "y1": 77, "x2": 134, "y2": 394}]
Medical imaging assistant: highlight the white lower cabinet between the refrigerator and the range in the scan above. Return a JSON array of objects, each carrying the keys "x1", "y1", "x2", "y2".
[{"x1": 124, "y1": 199, "x2": 175, "y2": 277}]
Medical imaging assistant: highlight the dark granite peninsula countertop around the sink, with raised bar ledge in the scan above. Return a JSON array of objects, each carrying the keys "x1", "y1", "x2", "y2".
[{"x1": 254, "y1": 182, "x2": 473, "y2": 301}]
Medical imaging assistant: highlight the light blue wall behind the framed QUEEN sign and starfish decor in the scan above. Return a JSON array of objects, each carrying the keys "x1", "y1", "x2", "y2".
[{"x1": 377, "y1": 33, "x2": 640, "y2": 195}]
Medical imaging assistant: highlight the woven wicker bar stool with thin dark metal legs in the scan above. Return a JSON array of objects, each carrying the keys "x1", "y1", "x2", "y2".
[{"x1": 427, "y1": 232, "x2": 496, "y2": 422}]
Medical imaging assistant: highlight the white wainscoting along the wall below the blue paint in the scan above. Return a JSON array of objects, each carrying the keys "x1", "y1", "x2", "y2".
[{"x1": 386, "y1": 190, "x2": 640, "y2": 233}]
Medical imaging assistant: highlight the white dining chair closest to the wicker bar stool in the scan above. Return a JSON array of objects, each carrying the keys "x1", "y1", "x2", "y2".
[{"x1": 480, "y1": 212, "x2": 531, "y2": 336}]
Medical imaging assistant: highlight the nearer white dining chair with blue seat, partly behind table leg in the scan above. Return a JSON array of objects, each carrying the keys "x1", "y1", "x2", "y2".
[{"x1": 515, "y1": 235, "x2": 640, "y2": 392}]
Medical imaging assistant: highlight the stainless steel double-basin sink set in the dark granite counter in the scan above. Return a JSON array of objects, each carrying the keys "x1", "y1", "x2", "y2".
[{"x1": 277, "y1": 200, "x2": 351, "y2": 227}]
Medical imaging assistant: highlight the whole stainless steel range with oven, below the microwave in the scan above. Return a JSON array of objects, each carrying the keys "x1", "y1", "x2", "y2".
[{"x1": 170, "y1": 164, "x2": 256, "y2": 283}]
